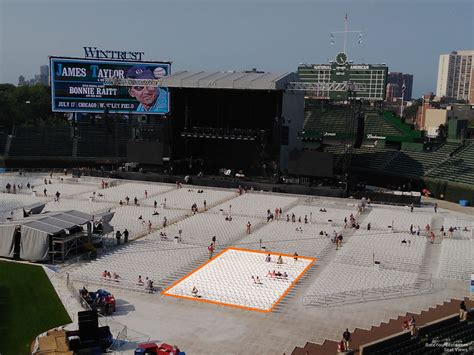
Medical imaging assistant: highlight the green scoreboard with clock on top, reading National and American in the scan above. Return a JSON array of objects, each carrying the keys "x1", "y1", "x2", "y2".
[{"x1": 298, "y1": 53, "x2": 388, "y2": 101}]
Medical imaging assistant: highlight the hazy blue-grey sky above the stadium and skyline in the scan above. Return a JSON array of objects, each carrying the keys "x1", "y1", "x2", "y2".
[{"x1": 0, "y1": 0, "x2": 474, "y2": 96}]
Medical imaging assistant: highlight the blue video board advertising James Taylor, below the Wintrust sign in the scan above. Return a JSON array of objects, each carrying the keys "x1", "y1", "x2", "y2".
[{"x1": 50, "y1": 57, "x2": 171, "y2": 115}]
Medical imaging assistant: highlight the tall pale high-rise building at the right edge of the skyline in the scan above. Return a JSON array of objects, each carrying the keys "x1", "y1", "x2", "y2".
[{"x1": 436, "y1": 51, "x2": 474, "y2": 103}]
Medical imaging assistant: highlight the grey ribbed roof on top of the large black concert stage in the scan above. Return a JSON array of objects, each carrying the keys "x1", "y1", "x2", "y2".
[{"x1": 161, "y1": 71, "x2": 297, "y2": 90}]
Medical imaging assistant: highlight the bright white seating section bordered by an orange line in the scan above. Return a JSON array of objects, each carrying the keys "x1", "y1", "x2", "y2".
[{"x1": 162, "y1": 248, "x2": 316, "y2": 312}]
